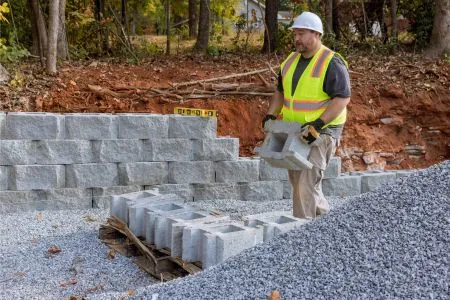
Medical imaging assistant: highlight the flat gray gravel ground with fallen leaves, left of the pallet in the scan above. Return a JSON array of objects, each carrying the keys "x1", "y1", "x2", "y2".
[{"x1": 0, "y1": 209, "x2": 155, "y2": 299}]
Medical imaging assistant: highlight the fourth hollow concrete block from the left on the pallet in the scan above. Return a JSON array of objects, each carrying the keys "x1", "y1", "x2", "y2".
[{"x1": 155, "y1": 211, "x2": 229, "y2": 256}]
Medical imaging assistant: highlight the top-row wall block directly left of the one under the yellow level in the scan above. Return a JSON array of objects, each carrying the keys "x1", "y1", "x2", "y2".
[{"x1": 117, "y1": 114, "x2": 169, "y2": 140}]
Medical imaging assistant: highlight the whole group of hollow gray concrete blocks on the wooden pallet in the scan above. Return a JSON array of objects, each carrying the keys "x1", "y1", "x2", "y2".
[{"x1": 110, "y1": 190, "x2": 307, "y2": 269}]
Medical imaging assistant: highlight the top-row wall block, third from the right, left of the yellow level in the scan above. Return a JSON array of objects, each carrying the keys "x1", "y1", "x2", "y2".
[{"x1": 65, "y1": 113, "x2": 117, "y2": 140}]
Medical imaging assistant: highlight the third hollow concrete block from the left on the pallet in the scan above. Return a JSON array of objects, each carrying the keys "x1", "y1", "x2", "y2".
[{"x1": 144, "y1": 201, "x2": 201, "y2": 244}]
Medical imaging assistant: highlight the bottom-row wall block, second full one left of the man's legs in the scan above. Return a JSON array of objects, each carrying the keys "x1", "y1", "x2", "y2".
[{"x1": 193, "y1": 183, "x2": 240, "y2": 201}]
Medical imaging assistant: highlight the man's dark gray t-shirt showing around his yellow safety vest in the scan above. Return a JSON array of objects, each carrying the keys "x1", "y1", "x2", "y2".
[{"x1": 277, "y1": 54, "x2": 351, "y2": 140}]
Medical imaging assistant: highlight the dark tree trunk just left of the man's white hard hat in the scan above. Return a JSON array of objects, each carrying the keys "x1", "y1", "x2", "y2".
[{"x1": 261, "y1": 0, "x2": 279, "y2": 53}]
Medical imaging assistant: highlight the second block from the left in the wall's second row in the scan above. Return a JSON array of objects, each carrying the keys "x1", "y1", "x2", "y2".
[{"x1": 35, "y1": 140, "x2": 94, "y2": 165}]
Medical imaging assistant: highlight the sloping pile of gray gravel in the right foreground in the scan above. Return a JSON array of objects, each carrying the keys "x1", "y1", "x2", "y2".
[{"x1": 92, "y1": 161, "x2": 450, "y2": 299}]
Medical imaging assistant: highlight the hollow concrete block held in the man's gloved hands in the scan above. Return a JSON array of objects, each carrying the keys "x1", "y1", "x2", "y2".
[{"x1": 256, "y1": 121, "x2": 312, "y2": 170}]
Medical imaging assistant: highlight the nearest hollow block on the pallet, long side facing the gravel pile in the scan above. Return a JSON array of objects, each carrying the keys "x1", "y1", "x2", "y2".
[{"x1": 201, "y1": 225, "x2": 263, "y2": 269}]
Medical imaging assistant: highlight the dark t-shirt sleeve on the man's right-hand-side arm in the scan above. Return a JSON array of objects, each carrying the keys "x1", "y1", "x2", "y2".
[{"x1": 323, "y1": 55, "x2": 352, "y2": 98}]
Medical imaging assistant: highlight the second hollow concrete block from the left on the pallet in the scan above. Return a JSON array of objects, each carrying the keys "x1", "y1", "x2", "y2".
[{"x1": 126, "y1": 194, "x2": 184, "y2": 237}]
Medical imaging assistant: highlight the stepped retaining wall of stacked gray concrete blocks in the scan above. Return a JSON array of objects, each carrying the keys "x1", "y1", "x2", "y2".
[{"x1": 0, "y1": 113, "x2": 414, "y2": 213}]
